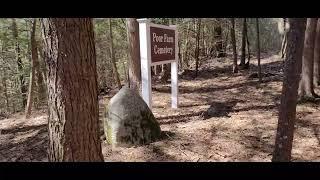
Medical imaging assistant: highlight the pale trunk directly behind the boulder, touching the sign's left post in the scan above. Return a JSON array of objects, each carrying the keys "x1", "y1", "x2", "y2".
[{"x1": 127, "y1": 18, "x2": 141, "y2": 91}]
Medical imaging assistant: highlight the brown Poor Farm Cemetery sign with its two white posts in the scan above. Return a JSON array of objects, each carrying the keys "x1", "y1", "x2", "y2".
[{"x1": 138, "y1": 19, "x2": 179, "y2": 109}]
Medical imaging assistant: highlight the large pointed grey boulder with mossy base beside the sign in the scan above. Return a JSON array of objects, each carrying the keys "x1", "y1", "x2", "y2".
[{"x1": 104, "y1": 87, "x2": 161, "y2": 147}]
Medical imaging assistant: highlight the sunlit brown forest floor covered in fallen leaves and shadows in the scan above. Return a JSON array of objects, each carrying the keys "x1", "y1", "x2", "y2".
[{"x1": 0, "y1": 55, "x2": 320, "y2": 162}]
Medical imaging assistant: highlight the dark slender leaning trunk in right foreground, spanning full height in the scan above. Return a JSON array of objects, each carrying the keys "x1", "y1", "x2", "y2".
[{"x1": 272, "y1": 18, "x2": 306, "y2": 161}]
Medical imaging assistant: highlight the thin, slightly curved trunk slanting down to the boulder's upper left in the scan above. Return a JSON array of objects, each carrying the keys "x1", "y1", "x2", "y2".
[{"x1": 109, "y1": 18, "x2": 122, "y2": 90}]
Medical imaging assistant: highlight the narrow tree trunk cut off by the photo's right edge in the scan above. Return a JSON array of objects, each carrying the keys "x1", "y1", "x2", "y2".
[{"x1": 313, "y1": 18, "x2": 320, "y2": 86}]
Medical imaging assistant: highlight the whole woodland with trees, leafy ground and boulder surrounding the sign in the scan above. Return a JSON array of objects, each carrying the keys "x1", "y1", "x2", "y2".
[{"x1": 0, "y1": 18, "x2": 320, "y2": 162}]
